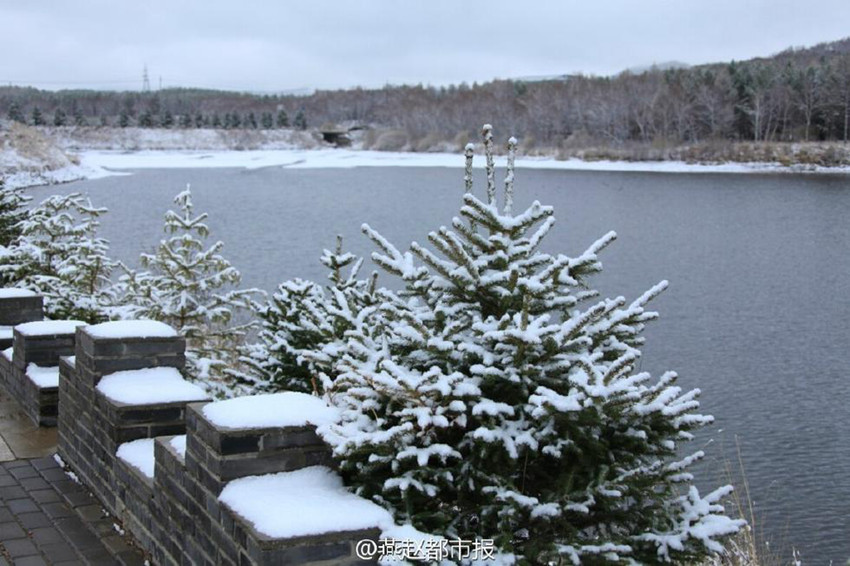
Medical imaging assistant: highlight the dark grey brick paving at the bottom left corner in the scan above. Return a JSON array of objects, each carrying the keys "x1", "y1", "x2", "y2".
[{"x1": 0, "y1": 456, "x2": 145, "y2": 566}]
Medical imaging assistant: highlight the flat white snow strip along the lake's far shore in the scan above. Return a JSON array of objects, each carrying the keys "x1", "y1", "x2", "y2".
[{"x1": 7, "y1": 149, "x2": 850, "y2": 187}]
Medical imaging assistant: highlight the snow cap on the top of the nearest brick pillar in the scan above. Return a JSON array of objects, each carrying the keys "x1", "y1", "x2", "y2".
[{"x1": 203, "y1": 391, "x2": 339, "y2": 428}]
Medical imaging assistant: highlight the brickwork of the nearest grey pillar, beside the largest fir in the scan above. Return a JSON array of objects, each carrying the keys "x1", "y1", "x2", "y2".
[{"x1": 178, "y1": 404, "x2": 372, "y2": 566}]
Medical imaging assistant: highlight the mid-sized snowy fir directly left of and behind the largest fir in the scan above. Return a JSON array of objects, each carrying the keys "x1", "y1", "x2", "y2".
[{"x1": 243, "y1": 236, "x2": 380, "y2": 394}]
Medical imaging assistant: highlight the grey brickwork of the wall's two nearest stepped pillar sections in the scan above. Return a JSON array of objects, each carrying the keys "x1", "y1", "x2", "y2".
[{"x1": 59, "y1": 323, "x2": 379, "y2": 566}]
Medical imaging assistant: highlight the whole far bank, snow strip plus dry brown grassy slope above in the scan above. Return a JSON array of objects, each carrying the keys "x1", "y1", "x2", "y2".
[{"x1": 0, "y1": 124, "x2": 850, "y2": 191}]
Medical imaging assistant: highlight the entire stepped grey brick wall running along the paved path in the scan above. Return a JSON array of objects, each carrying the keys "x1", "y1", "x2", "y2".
[{"x1": 0, "y1": 295, "x2": 380, "y2": 566}]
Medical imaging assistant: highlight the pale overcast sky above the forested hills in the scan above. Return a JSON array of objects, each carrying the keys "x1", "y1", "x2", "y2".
[{"x1": 0, "y1": 0, "x2": 850, "y2": 91}]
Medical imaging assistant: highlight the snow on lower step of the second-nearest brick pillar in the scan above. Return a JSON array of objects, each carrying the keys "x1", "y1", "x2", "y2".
[{"x1": 97, "y1": 367, "x2": 207, "y2": 405}]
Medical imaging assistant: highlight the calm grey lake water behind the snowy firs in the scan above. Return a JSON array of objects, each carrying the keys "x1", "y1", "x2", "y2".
[{"x1": 34, "y1": 164, "x2": 850, "y2": 564}]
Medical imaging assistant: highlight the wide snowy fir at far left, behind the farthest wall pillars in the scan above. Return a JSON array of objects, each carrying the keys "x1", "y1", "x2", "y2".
[{"x1": 0, "y1": 193, "x2": 116, "y2": 323}]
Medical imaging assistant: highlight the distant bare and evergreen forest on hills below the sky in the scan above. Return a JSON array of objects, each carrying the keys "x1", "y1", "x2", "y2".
[{"x1": 0, "y1": 38, "x2": 850, "y2": 149}]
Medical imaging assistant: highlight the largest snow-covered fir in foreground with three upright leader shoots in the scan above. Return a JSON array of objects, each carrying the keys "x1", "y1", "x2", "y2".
[{"x1": 314, "y1": 126, "x2": 742, "y2": 564}]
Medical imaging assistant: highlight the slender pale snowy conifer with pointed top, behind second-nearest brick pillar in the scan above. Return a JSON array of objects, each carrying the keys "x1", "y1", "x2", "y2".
[{"x1": 119, "y1": 187, "x2": 257, "y2": 397}]
